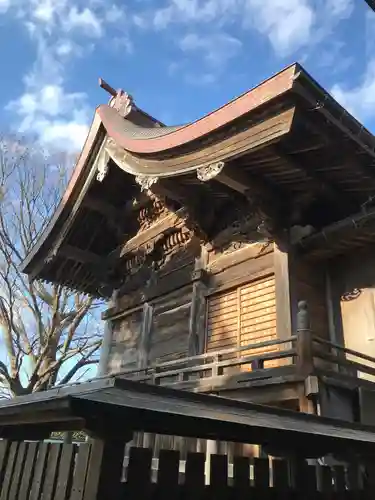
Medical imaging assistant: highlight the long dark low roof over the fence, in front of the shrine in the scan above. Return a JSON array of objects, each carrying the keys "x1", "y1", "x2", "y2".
[{"x1": 0, "y1": 377, "x2": 375, "y2": 456}]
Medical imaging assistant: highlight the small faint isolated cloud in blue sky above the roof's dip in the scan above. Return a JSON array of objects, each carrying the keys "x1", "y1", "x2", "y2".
[{"x1": 180, "y1": 33, "x2": 242, "y2": 66}]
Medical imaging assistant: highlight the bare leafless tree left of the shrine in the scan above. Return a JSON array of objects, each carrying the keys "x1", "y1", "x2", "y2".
[{"x1": 0, "y1": 138, "x2": 101, "y2": 396}]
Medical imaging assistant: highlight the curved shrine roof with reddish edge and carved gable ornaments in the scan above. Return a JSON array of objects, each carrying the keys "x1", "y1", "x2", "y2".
[{"x1": 22, "y1": 64, "x2": 375, "y2": 295}]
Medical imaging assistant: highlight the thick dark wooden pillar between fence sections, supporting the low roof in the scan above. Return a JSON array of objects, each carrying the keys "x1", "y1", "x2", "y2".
[{"x1": 83, "y1": 438, "x2": 125, "y2": 500}]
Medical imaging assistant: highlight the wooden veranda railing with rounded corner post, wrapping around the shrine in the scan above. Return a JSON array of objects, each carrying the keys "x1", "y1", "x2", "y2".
[{"x1": 98, "y1": 301, "x2": 375, "y2": 387}]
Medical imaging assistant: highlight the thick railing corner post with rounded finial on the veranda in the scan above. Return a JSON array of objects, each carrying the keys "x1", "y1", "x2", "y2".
[{"x1": 296, "y1": 300, "x2": 314, "y2": 377}]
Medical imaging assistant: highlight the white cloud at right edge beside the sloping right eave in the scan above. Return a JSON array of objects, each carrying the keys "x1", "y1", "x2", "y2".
[{"x1": 331, "y1": 58, "x2": 375, "y2": 120}]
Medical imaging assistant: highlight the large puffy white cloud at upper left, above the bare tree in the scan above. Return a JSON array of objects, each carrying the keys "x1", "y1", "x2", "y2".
[{"x1": 4, "y1": 0, "x2": 131, "y2": 152}]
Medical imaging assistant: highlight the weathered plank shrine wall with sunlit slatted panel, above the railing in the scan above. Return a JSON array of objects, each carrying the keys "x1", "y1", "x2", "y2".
[{"x1": 104, "y1": 240, "x2": 276, "y2": 373}]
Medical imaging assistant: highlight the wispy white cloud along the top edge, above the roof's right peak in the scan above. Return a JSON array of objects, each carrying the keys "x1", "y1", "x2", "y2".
[{"x1": 148, "y1": 0, "x2": 354, "y2": 57}]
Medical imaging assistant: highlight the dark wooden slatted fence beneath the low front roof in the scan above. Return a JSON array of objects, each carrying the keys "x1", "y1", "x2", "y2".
[{"x1": 0, "y1": 441, "x2": 375, "y2": 500}]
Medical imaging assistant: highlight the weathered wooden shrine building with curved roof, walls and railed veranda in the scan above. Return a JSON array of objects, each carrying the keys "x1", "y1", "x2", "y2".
[{"x1": 23, "y1": 65, "x2": 375, "y2": 422}]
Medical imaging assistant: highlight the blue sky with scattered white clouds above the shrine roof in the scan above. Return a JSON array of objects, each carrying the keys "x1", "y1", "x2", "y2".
[{"x1": 0, "y1": 0, "x2": 375, "y2": 151}]
